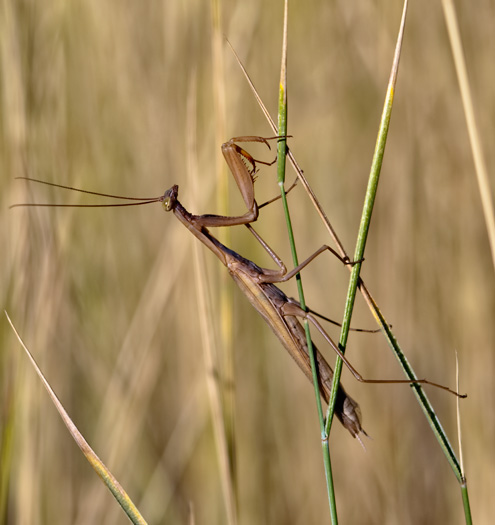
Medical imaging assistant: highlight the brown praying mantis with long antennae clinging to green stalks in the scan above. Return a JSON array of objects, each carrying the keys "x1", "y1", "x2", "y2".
[{"x1": 15, "y1": 136, "x2": 466, "y2": 439}]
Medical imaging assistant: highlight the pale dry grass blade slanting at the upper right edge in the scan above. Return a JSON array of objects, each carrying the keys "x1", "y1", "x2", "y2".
[{"x1": 442, "y1": 0, "x2": 495, "y2": 267}]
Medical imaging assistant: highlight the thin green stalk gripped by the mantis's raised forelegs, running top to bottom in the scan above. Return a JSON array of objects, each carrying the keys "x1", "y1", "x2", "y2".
[{"x1": 277, "y1": 0, "x2": 338, "y2": 524}]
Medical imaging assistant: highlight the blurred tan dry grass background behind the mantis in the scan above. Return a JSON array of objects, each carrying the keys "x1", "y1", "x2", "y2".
[{"x1": 0, "y1": 0, "x2": 495, "y2": 525}]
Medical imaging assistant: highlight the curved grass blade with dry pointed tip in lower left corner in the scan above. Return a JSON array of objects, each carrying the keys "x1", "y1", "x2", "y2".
[{"x1": 4, "y1": 310, "x2": 146, "y2": 525}]
